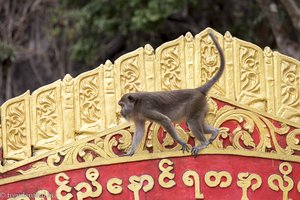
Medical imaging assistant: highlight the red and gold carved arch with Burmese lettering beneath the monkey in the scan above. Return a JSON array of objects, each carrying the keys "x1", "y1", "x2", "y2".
[{"x1": 0, "y1": 28, "x2": 300, "y2": 200}]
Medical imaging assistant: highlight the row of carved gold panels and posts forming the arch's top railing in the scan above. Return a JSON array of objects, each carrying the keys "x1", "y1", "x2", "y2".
[{"x1": 1, "y1": 28, "x2": 300, "y2": 165}]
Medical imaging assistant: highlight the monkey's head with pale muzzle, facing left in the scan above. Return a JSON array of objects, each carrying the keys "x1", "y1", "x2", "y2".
[{"x1": 119, "y1": 93, "x2": 137, "y2": 120}]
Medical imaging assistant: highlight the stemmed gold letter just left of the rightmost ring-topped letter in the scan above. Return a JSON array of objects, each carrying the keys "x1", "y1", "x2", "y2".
[{"x1": 237, "y1": 172, "x2": 262, "y2": 200}]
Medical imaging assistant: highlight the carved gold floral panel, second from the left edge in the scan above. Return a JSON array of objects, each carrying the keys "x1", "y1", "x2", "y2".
[{"x1": 32, "y1": 81, "x2": 63, "y2": 154}]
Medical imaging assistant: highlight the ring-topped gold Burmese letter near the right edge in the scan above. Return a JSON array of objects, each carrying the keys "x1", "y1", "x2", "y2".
[{"x1": 268, "y1": 162, "x2": 294, "y2": 200}]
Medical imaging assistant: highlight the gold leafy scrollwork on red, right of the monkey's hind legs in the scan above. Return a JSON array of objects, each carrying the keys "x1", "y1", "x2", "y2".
[{"x1": 214, "y1": 106, "x2": 299, "y2": 155}]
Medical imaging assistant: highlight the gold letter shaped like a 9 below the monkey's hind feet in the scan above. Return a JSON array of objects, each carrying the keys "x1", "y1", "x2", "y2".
[{"x1": 182, "y1": 170, "x2": 204, "y2": 199}]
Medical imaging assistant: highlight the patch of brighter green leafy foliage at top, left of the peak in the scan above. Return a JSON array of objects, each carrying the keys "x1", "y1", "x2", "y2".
[{"x1": 55, "y1": 0, "x2": 197, "y2": 64}]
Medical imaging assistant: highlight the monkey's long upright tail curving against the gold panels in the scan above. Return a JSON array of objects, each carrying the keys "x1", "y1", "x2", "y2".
[{"x1": 197, "y1": 32, "x2": 225, "y2": 95}]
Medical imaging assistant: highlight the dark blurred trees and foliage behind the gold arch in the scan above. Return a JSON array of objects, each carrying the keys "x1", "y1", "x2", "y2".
[{"x1": 0, "y1": 0, "x2": 300, "y2": 104}]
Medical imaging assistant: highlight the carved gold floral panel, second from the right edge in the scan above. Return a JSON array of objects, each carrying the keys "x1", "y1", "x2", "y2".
[{"x1": 234, "y1": 39, "x2": 267, "y2": 111}]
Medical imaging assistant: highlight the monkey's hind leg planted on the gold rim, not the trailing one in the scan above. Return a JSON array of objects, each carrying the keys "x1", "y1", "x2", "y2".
[{"x1": 187, "y1": 119, "x2": 209, "y2": 157}]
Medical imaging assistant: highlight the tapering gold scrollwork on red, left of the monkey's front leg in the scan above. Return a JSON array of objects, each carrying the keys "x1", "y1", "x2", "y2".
[{"x1": 18, "y1": 126, "x2": 133, "y2": 174}]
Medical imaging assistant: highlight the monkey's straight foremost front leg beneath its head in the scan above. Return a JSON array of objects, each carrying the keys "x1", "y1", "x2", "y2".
[{"x1": 124, "y1": 120, "x2": 145, "y2": 156}]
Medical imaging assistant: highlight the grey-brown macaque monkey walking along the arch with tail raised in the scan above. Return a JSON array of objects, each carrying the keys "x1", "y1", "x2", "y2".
[{"x1": 119, "y1": 32, "x2": 225, "y2": 156}]
